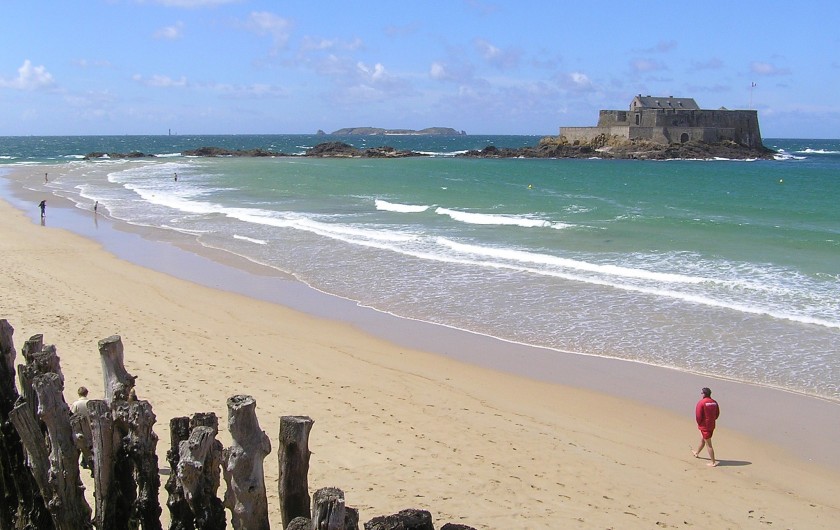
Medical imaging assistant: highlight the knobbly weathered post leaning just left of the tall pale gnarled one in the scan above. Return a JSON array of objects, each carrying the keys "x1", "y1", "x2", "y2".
[{"x1": 178, "y1": 426, "x2": 225, "y2": 530}]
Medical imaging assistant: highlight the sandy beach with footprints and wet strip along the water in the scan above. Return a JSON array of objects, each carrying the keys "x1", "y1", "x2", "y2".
[{"x1": 0, "y1": 163, "x2": 840, "y2": 529}]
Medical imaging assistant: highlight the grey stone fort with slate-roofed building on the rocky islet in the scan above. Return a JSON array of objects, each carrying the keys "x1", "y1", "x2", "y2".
[{"x1": 560, "y1": 94, "x2": 762, "y2": 149}]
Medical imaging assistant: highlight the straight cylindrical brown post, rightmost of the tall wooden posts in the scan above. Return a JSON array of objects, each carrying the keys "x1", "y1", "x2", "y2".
[{"x1": 277, "y1": 416, "x2": 314, "y2": 528}]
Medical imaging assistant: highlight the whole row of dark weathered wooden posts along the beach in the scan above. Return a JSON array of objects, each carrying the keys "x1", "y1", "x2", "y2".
[{"x1": 0, "y1": 319, "x2": 470, "y2": 530}]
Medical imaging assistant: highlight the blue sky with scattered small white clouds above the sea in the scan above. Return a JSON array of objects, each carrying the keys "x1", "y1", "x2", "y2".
[{"x1": 0, "y1": 0, "x2": 840, "y2": 138}]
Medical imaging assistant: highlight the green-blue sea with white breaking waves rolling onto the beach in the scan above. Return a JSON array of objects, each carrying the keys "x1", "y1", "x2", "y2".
[{"x1": 0, "y1": 135, "x2": 840, "y2": 402}]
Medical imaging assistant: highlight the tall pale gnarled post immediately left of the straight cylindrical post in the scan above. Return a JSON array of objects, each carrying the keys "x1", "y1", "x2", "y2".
[{"x1": 223, "y1": 395, "x2": 271, "y2": 530}]
